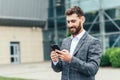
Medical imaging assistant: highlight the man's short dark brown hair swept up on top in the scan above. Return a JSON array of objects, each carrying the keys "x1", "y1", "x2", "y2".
[{"x1": 65, "y1": 6, "x2": 84, "y2": 17}]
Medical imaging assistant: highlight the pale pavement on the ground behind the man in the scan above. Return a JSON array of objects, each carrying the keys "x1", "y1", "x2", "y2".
[{"x1": 0, "y1": 61, "x2": 120, "y2": 80}]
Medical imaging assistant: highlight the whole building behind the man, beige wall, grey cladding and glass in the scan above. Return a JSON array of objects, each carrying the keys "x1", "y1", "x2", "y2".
[{"x1": 0, "y1": 0, "x2": 120, "y2": 64}]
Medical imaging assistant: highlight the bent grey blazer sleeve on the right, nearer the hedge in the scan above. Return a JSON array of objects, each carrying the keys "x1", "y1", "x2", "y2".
[{"x1": 70, "y1": 40, "x2": 102, "y2": 76}]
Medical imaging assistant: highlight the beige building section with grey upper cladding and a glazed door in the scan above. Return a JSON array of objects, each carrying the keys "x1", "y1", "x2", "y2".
[{"x1": 0, "y1": 0, "x2": 48, "y2": 64}]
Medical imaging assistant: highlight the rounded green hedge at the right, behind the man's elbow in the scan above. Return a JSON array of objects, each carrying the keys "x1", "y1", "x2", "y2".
[{"x1": 100, "y1": 48, "x2": 120, "y2": 67}]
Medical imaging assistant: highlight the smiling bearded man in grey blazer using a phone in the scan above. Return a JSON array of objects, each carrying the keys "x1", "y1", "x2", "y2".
[{"x1": 50, "y1": 6, "x2": 102, "y2": 80}]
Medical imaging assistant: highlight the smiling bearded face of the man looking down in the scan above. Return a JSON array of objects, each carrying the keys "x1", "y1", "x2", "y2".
[{"x1": 66, "y1": 14, "x2": 84, "y2": 35}]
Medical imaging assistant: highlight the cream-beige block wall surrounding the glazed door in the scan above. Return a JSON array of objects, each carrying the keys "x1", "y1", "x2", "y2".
[{"x1": 0, "y1": 26, "x2": 43, "y2": 64}]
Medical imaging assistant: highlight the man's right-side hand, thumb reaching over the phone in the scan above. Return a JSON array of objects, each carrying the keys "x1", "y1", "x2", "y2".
[{"x1": 56, "y1": 49, "x2": 72, "y2": 62}]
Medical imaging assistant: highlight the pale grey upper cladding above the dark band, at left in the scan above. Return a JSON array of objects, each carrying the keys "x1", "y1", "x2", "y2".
[{"x1": 0, "y1": 0, "x2": 48, "y2": 20}]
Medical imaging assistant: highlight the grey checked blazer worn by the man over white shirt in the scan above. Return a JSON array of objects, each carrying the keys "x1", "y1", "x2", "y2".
[{"x1": 52, "y1": 32, "x2": 102, "y2": 80}]
